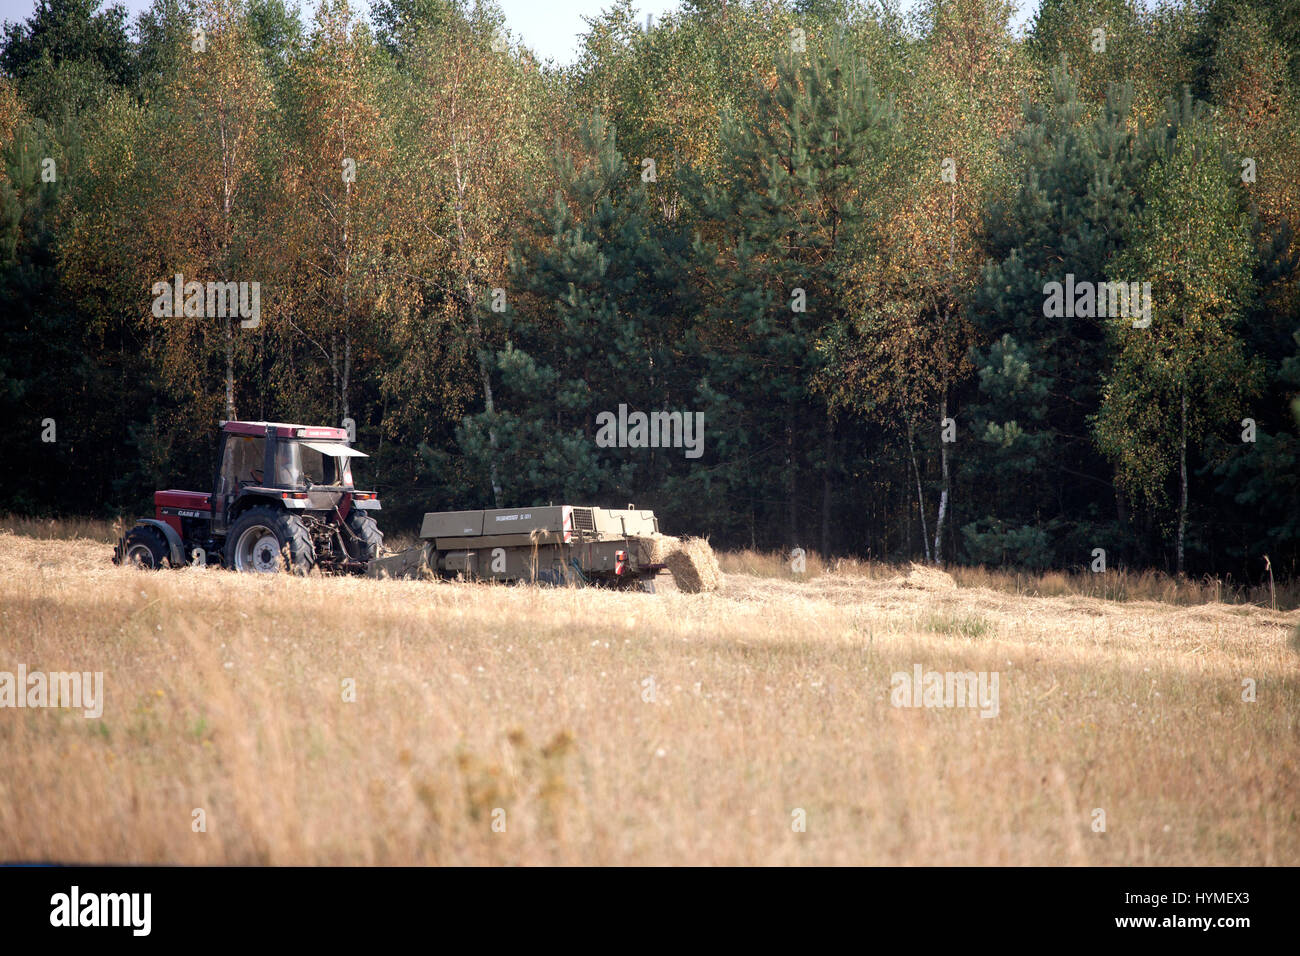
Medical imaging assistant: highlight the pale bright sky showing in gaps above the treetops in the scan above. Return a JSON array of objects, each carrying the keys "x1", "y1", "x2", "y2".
[{"x1": 0, "y1": 0, "x2": 1036, "y2": 64}]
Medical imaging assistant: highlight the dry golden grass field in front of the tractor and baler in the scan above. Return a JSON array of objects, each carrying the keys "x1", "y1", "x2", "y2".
[{"x1": 0, "y1": 533, "x2": 1300, "y2": 865}]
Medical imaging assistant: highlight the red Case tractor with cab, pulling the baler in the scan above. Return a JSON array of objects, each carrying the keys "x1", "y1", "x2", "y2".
[{"x1": 113, "y1": 421, "x2": 384, "y2": 574}]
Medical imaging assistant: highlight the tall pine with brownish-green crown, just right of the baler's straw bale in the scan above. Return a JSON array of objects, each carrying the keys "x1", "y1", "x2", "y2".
[{"x1": 694, "y1": 38, "x2": 892, "y2": 550}]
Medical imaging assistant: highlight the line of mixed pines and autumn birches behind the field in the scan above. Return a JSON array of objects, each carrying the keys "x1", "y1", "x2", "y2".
[{"x1": 0, "y1": 0, "x2": 1300, "y2": 579}]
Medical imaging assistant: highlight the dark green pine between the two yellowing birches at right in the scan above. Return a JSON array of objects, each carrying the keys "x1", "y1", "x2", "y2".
[{"x1": 962, "y1": 69, "x2": 1144, "y2": 567}]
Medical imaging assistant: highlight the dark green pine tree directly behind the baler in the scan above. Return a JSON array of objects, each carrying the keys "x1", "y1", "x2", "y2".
[{"x1": 458, "y1": 114, "x2": 694, "y2": 515}]
